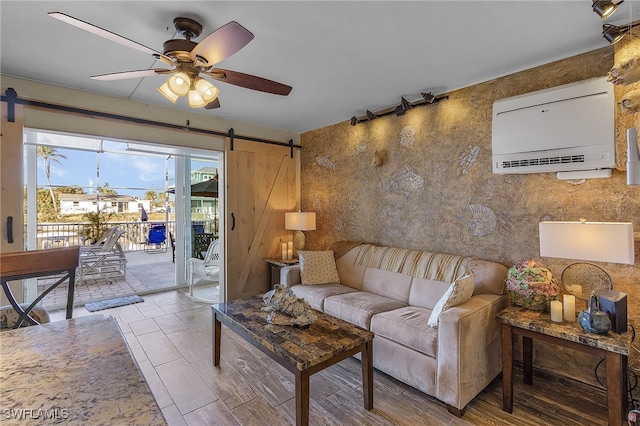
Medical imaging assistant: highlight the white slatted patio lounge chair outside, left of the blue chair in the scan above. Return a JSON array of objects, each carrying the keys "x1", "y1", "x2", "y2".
[{"x1": 76, "y1": 229, "x2": 127, "y2": 283}]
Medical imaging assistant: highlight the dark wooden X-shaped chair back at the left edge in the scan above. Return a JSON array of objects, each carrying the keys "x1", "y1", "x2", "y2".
[{"x1": 0, "y1": 246, "x2": 80, "y2": 328}]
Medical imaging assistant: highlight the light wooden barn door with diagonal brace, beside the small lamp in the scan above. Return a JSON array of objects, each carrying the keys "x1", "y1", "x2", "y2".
[{"x1": 225, "y1": 139, "x2": 296, "y2": 300}]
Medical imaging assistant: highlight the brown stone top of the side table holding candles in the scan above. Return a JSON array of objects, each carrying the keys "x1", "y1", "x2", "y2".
[{"x1": 496, "y1": 306, "x2": 632, "y2": 356}]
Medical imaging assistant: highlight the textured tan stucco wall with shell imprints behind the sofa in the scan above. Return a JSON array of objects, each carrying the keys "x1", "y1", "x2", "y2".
[{"x1": 301, "y1": 37, "x2": 640, "y2": 383}]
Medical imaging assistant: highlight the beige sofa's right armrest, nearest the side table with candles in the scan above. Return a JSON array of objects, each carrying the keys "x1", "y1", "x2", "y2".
[{"x1": 436, "y1": 294, "x2": 508, "y2": 410}]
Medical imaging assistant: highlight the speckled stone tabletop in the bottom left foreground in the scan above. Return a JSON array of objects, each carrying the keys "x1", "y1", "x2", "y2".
[{"x1": 0, "y1": 315, "x2": 167, "y2": 425}]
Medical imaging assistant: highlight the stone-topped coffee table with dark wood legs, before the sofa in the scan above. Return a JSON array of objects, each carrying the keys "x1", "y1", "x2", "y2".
[{"x1": 212, "y1": 296, "x2": 373, "y2": 425}]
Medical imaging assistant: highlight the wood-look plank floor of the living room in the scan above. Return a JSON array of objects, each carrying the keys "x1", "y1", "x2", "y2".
[{"x1": 52, "y1": 290, "x2": 607, "y2": 426}]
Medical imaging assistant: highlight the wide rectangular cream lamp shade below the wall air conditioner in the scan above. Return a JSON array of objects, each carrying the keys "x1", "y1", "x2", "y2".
[{"x1": 539, "y1": 221, "x2": 635, "y2": 265}]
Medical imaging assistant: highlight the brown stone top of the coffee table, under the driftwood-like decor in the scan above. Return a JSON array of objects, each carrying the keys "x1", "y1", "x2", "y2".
[{"x1": 212, "y1": 296, "x2": 373, "y2": 371}]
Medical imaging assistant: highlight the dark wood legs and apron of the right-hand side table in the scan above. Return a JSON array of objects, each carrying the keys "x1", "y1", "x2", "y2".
[{"x1": 502, "y1": 324, "x2": 629, "y2": 426}]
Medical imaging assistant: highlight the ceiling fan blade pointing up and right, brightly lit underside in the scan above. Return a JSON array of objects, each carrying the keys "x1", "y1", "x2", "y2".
[{"x1": 191, "y1": 21, "x2": 253, "y2": 66}]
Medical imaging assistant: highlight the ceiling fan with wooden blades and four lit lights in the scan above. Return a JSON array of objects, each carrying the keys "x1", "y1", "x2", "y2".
[{"x1": 48, "y1": 12, "x2": 291, "y2": 109}]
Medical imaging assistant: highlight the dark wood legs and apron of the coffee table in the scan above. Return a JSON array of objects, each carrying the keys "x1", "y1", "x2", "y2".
[{"x1": 213, "y1": 305, "x2": 373, "y2": 426}]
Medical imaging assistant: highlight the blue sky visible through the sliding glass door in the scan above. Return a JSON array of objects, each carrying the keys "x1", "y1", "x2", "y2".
[{"x1": 25, "y1": 132, "x2": 217, "y2": 198}]
